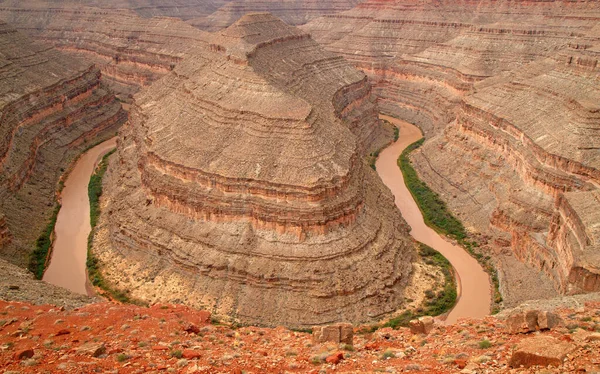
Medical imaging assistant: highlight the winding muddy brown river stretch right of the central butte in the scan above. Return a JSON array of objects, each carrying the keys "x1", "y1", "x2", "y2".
[{"x1": 375, "y1": 115, "x2": 491, "y2": 323}]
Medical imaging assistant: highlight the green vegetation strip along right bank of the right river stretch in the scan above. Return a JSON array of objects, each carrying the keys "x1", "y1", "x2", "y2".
[{"x1": 398, "y1": 138, "x2": 502, "y2": 313}]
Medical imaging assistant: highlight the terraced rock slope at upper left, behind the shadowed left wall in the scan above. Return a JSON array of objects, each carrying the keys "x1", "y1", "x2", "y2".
[{"x1": 0, "y1": 5, "x2": 213, "y2": 101}]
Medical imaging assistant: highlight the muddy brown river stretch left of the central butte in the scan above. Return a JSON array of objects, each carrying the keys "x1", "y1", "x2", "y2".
[{"x1": 43, "y1": 138, "x2": 117, "y2": 294}]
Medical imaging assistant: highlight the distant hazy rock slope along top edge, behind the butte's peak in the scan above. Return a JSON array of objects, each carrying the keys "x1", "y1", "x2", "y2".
[{"x1": 187, "y1": 0, "x2": 362, "y2": 31}]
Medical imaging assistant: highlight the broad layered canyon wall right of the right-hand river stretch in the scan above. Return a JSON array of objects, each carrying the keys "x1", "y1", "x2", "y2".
[{"x1": 301, "y1": 0, "x2": 600, "y2": 305}]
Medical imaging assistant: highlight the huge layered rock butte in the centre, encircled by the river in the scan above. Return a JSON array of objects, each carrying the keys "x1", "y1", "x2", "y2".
[{"x1": 94, "y1": 13, "x2": 413, "y2": 326}]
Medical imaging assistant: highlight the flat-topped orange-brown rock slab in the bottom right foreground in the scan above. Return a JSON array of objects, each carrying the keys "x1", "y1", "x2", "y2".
[{"x1": 510, "y1": 336, "x2": 576, "y2": 367}]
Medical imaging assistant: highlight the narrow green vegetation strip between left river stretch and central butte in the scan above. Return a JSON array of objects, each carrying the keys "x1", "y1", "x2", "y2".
[{"x1": 86, "y1": 150, "x2": 145, "y2": 305}]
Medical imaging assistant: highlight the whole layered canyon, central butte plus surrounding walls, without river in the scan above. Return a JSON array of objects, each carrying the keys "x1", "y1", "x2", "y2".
[{"x1": 0, "y1": 0, "x2": 600, "y2": 346}]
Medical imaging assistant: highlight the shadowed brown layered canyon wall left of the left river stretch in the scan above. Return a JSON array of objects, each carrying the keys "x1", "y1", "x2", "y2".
[{"x1": 0, "y1": 23, "x2": 127, "y2": 265}]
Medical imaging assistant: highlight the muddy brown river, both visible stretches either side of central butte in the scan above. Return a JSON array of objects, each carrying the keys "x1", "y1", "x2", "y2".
[{"x1": 43, "y1": 115, "x2": 491, "y2": 323}]
